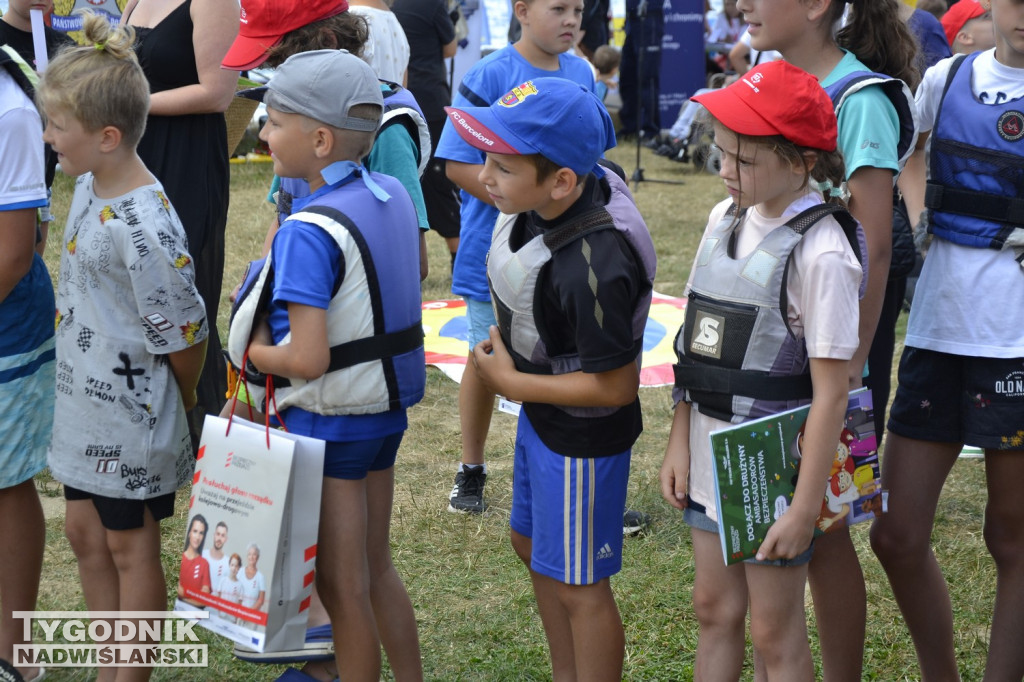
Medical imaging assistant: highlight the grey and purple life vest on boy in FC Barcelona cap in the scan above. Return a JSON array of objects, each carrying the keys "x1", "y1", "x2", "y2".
[{"x1": 487, "y1": 168, "x2": 656, "y2": 417}]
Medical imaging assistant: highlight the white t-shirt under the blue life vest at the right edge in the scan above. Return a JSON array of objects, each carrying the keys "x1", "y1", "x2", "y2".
[{"x1": 906, "y1": 49, "x2": 1024, "y2": 357}]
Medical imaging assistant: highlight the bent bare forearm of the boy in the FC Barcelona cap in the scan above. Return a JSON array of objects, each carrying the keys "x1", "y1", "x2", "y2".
[{"x1": 473, "y1": 326, "x2": 640, "y2": 408}]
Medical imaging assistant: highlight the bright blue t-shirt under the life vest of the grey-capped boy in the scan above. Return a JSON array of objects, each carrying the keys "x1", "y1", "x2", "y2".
[{"x1": 267, "y1": 176, "x2": 409, "y2": 441}]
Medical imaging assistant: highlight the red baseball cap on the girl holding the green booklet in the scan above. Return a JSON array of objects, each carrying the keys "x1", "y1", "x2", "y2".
[{"x1": 692, "y1": 60, "x2": 837, "y2": 152}]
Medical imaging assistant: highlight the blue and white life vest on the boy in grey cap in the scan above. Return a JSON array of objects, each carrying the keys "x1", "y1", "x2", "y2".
[{"x1": 227, "y1": 173, "x2": 426, "y2": 415}]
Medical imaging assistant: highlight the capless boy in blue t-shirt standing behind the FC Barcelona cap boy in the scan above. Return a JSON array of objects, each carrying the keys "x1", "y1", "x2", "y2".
[{"x1": 435, "y1": 0, "x2": 594, "y2": 513}]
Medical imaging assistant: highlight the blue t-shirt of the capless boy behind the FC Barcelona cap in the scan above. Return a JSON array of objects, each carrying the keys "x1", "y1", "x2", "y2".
[{"x1": 434, "y1": 45, "x2": 594, "y2": 302}]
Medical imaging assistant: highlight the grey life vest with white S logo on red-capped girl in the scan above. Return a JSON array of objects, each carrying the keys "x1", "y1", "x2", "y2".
[{"x1": 674, "y1": 204, "x2": 861, "y2": 424}]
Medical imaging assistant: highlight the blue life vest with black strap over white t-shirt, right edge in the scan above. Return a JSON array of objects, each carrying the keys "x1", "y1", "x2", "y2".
[{"x1": 925, "y1": 53, "x2": 1024, "y2": 249}]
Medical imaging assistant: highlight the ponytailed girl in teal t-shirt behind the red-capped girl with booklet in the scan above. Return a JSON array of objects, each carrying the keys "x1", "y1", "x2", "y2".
[{"x1": 738, "y1": 0, "x2": 920, "y2": 682}]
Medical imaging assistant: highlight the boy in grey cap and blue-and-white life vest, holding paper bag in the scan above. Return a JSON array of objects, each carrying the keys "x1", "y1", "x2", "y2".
[{"x1": 227, "y1": 50, "x2": 426, "y2": 680}]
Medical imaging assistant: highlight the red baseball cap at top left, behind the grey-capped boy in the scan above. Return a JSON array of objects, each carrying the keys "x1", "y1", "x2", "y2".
[{"x1": 220, "y1": 0, "x2": 348, "y2": 71}]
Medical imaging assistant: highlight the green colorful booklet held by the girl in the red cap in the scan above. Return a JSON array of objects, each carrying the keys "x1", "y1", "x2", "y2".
[{"x1": 711, "y1": 388, "x2": 888, "y2": 564}]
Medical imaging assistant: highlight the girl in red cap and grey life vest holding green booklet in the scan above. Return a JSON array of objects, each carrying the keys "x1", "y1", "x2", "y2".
[{"x1": 660, "y1": 61, "x2": 863, "y2": 681}]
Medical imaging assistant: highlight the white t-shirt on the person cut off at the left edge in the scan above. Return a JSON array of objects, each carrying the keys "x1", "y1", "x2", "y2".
[{"x1": 0, "y1": 69, "x2": 46, "y2": 211}]
